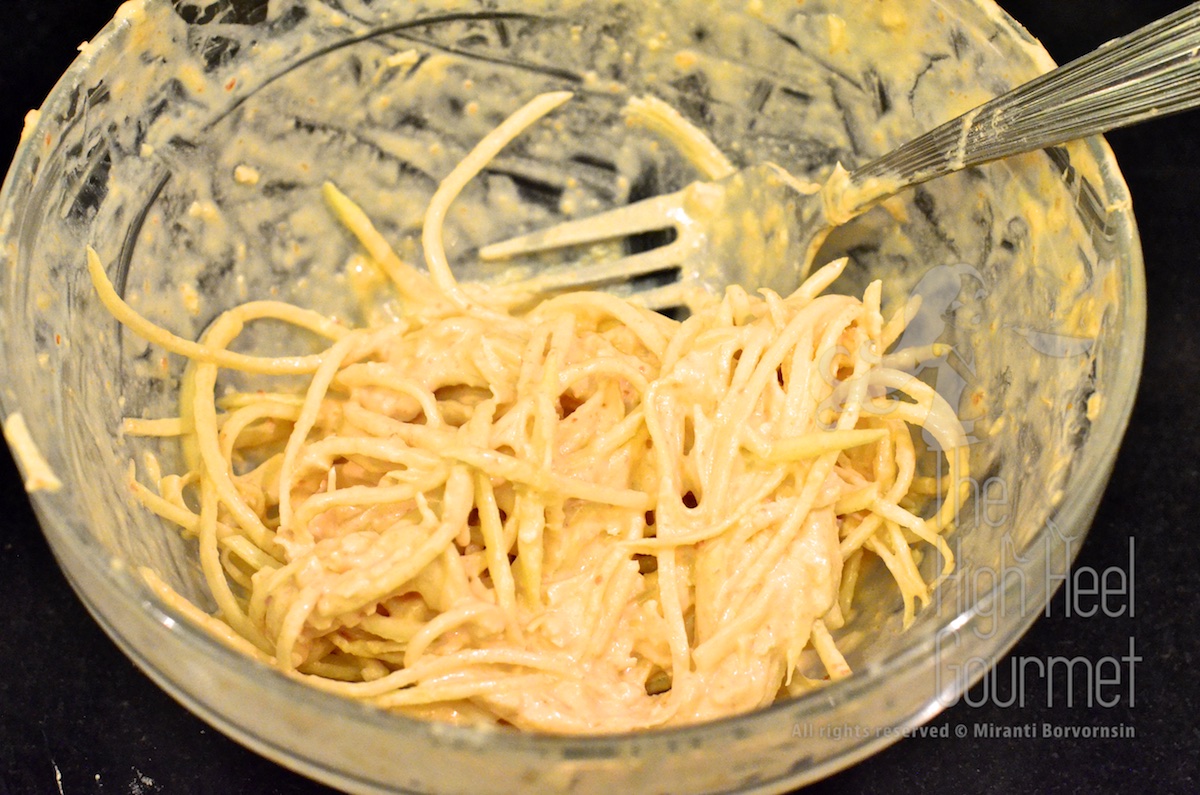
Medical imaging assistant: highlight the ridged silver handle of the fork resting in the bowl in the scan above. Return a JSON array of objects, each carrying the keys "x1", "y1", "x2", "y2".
[{"x1": 851, "y1": 2, "x2": 1200, "y2": 195}]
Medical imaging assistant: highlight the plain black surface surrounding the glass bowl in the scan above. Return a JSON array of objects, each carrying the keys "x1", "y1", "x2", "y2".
[{"x1": 0, "y1": 0, "x2": 1200, "y2": 795}]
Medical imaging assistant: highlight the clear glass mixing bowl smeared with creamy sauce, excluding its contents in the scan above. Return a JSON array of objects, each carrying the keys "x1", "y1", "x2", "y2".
[{"x1": 0, "y1": 0, "x2": 1145, "y2": 793}]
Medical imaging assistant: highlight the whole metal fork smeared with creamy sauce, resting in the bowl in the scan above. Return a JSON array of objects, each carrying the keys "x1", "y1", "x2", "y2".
[{"x1": 480, "y1": 2, "x2": 1200, "y2": 309}]
